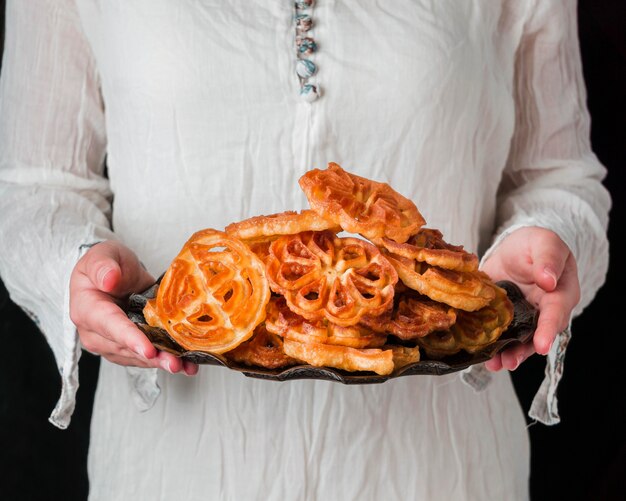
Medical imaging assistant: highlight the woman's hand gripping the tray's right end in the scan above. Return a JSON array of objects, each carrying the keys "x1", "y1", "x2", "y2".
[{"x1": 482, "y1": 226, "x2": 580, "y2": 371}]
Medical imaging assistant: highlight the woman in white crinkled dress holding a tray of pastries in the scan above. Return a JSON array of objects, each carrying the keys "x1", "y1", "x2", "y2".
[{"x1": 0, "y1": 0, "x2": 610, "y2": 500}]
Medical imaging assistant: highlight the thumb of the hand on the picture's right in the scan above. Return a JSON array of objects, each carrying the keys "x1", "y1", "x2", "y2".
[{"x1": 532, "y1": 232, "x2": 570, "y2": 292}]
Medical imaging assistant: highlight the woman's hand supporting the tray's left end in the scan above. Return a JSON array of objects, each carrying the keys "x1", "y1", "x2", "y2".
[{"x1": 70, "y1": 240, "x2": 198, "y2": 376}]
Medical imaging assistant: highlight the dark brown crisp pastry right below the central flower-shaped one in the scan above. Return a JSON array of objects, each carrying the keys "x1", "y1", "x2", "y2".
[{"x1": 360, "y1": 292, "x2": 456, "y2": 341}]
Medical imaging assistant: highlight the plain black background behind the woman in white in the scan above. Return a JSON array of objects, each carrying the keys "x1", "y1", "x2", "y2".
[{"x1": 0, "y1": 0, "x2": 626, "y2": 501}]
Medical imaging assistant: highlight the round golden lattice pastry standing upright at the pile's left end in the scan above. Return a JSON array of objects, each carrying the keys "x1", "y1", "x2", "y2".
[{"x1": 144, "y1": 229, "x2": 270, "y2": 354}]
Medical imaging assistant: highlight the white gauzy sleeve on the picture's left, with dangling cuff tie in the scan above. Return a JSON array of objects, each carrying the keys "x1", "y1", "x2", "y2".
[{"x1": 0, "y1": 0, "x2": 113, "y2": 428}]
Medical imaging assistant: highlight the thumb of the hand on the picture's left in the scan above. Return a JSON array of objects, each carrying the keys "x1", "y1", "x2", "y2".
[{"x1": 87, "y1": 242, "x2": 154, "y2": 298}]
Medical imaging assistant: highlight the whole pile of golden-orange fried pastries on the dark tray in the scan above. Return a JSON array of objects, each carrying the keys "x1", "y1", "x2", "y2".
[{"x1": 143, "y1": 163, "x2": 513, "y2": 375}]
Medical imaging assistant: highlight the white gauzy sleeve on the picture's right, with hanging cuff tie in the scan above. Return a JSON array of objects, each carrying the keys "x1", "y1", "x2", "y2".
[{"x1": 486, "y1": 0, "x2": 611, "y2": 423}]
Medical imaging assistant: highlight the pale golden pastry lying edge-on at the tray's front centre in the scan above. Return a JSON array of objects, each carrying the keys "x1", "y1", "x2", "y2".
[{"x1": 284, "y1": 338, "x2": 394, "y2": 376}]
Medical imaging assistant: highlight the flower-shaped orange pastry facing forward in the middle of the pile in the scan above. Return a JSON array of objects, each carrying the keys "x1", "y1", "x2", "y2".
[{"x1": 266, "y1": 231, "x2": 398, "y2": 326}]
